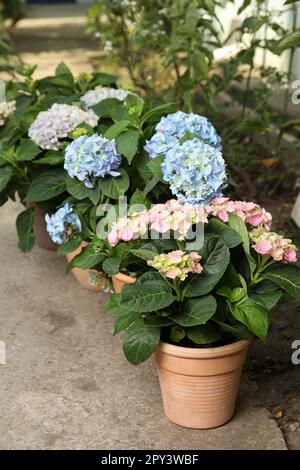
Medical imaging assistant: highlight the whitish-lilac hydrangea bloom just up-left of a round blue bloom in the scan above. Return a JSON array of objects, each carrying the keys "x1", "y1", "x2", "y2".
[{"x1": 28, "y1": 103, "x2": 98, "y2": 150}]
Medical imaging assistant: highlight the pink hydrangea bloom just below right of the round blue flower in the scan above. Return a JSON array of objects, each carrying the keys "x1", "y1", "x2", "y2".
[{"x1": 205, "y1": 197, "x2": 272, "y2": 230}]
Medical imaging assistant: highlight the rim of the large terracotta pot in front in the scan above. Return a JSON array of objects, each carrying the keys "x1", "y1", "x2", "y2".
[{"x1": 157, "y1": 339, "x2": 252, "y2": 359}]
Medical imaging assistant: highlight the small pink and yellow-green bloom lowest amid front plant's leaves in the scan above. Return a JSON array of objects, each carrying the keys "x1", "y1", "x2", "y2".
[{"x1": 148, "y1": 250, "x2": 203, "y2": 281}]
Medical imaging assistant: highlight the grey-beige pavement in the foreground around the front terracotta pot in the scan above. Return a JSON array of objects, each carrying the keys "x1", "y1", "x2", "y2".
[{"x1": 0, "y1": 203, "x2": 286, "y2": 450}]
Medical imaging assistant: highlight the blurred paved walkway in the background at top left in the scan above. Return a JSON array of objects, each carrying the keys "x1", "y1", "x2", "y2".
[{"x1": 13, "y1": 4, "x2": 101, "y2": 78}]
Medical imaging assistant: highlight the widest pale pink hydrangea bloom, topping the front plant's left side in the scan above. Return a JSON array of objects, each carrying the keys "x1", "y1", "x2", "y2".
[{"x1": 108, "y1": 199, "x2": 207, "y2": 247}]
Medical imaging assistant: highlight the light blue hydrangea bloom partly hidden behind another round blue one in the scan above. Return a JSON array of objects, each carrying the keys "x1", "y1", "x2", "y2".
[{"x1": 144, "y1": 111, "x2": 221, "y2": 158}]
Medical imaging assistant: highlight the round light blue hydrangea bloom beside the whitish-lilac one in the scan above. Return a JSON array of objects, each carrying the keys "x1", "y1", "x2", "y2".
[{"x1": 64, "y1": 134, "x2": 121, "y2": 188}]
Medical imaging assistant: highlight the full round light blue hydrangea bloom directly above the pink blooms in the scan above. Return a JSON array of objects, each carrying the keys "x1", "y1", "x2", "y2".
[{"x1": 162, "y1": 138, "x2": 227, "y2": 204}]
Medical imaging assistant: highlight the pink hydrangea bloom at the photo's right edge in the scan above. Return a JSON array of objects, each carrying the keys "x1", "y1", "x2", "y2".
[{"x1": 249, "y1": 227, "x2": 297, "y2": 263}]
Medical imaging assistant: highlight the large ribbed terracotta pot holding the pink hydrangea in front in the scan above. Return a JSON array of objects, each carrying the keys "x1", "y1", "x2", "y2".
[{"x1": 154, "y1": 340, "x2": 250, "y2": 429}]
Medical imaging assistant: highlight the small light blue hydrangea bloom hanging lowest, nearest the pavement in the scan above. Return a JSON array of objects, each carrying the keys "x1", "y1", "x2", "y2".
[{"x1": 45, "y1": 203, "x2": 82, "y2": 245}]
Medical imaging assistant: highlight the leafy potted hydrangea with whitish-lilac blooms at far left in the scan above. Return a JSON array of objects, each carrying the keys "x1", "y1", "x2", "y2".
[{"x1": 0, "y1": 64, "x2": 159, "y2": 255}]
